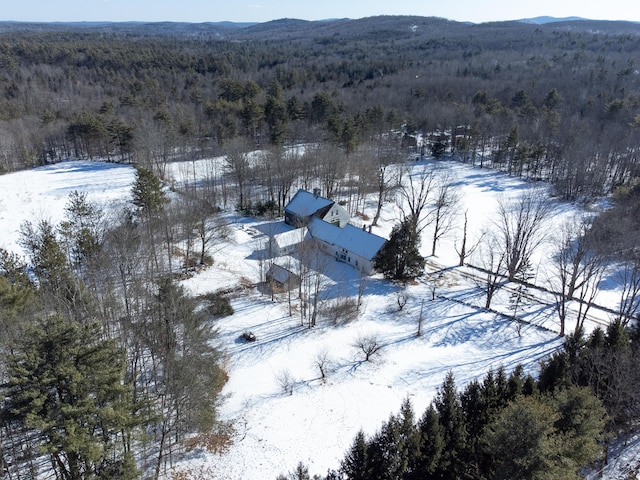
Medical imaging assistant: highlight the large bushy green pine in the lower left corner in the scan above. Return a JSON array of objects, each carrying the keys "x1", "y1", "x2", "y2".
[{"x1": 3, "y1": 316, "x2": 138, "y2": 480}]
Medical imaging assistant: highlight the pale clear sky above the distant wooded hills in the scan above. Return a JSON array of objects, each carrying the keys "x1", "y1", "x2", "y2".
[{"x1": 0, "y1": 0, "x2": 640, "y2": 23}]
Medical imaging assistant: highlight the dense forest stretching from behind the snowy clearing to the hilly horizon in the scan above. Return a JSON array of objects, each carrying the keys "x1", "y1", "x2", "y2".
[{"x1": 0, "y1": 17, "x2": 640, "y2": 199}]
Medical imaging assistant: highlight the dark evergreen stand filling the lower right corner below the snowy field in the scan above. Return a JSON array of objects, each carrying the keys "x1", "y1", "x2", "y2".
[{"x1": 279, "y1": 322, "x2": 640, "y2": 480}]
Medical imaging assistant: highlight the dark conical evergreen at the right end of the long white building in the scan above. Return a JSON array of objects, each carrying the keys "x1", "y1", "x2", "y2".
[{"x1": 374, "y1": 218, "x2": 425, "y2": 281}]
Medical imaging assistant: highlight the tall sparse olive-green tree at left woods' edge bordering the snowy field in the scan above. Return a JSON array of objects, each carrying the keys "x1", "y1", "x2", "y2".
[{"x1": 143, "y1": 276, "x2": 225, "y2": 475}]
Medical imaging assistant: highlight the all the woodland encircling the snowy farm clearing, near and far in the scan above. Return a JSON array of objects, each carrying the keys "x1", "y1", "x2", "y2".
[{"x1": 0, "y1": 17, "x2": 640, "y2": 479}]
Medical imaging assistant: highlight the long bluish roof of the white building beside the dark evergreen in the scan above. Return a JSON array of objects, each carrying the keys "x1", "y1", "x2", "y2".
[{"x1": 308, "y1": 218, "x2": 386, "y2": 260}]
